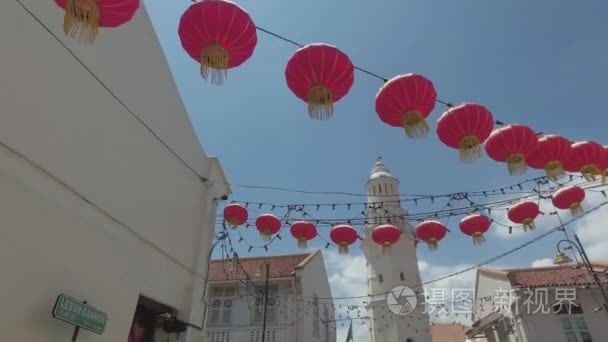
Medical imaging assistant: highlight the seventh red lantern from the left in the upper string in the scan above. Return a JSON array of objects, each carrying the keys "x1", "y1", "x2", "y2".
[{"x1": 526, "y1": 134, "x2": 571, "y2": 181}]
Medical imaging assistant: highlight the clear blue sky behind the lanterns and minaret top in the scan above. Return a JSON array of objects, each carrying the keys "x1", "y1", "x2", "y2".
[{"x1": 145, "y1": 0, "x2": 608, "y2": 336}]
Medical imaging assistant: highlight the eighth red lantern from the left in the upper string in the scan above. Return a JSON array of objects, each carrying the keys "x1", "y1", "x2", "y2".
[{"x1": 564, "y1": 141, "x2": 604, "y2": 182}]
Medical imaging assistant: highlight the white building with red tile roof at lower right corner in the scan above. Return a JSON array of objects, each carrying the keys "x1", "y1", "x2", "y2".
[{"x1": 467, "y1": 263, "x2": 608, "y2": 342}]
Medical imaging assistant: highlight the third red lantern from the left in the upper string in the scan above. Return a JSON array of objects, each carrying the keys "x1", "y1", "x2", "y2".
[{"x1": 285, "y1": 44, "x2": 355, "y2": 120}]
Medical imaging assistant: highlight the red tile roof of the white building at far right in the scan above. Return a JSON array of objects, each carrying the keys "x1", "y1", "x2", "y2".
[{"x1": 507, "y1": 264, "x2": 608, "y2": 287}]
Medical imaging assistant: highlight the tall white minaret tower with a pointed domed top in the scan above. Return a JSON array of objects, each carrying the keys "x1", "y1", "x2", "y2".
[{"x1": 362, "y1": 158, "x2": 431, "y2": 342}]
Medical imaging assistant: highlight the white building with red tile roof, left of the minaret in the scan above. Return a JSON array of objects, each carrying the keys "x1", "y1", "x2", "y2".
[{"x1": 205, "y1": 250, "x2": 336, "y2": 342}]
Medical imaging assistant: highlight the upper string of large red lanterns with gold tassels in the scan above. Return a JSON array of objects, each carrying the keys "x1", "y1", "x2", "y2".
[{"x1": 55, "y1": 0, "x2": 608, "y2": 184}]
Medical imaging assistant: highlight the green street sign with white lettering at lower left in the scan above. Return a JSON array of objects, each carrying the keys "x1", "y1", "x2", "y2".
[{"x1": 53, "y1": 294, "x2": 108, "y2": 335}]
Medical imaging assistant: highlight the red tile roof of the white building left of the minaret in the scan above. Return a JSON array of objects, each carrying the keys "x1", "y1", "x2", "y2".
[{"x1": 209, "y1": 251, "x2": 318, "y2": 281}]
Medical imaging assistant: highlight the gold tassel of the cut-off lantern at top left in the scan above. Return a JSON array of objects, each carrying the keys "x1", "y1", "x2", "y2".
[{"x1": 63, "y1": 0, "x2": 99, "y2": 44}]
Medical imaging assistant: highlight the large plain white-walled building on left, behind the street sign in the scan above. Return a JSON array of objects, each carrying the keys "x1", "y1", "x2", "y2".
[{"x1": 0, "y1": 0, "x2": 230, "y2": 342}]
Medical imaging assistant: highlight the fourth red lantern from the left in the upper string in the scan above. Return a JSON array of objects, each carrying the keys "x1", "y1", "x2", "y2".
[{"x1": 376, "y1": 74, "x2": 437, "y2": 138}]
